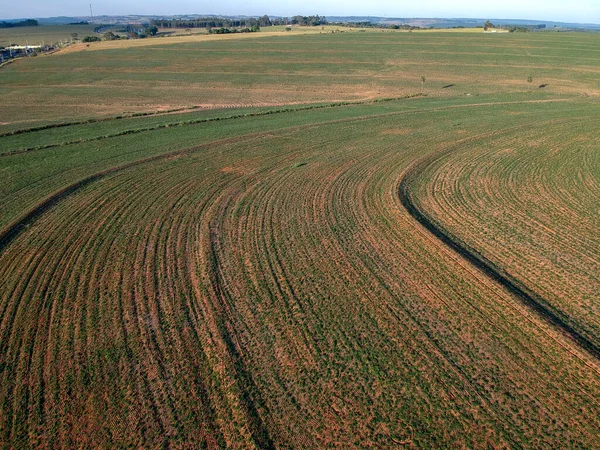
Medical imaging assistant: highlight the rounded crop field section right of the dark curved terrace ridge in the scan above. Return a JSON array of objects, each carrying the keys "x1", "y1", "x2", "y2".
[{"x1": 413, "y1": 113, "x2": 600, "y2": 354}]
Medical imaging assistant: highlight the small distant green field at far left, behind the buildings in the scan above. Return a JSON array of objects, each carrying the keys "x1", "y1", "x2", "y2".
[{"x1": 0, "y1": 24, "x2": 98, "y2": 47}]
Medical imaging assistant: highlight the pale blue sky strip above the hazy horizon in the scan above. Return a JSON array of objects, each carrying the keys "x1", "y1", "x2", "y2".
[{"x1": 0, "y1": 0, "x2": 600, "y2": 23}]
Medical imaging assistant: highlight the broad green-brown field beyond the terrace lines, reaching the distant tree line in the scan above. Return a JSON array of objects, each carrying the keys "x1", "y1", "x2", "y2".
[{"x1": 0, "y1": 27, "x2": 600, "y2": 128}]
